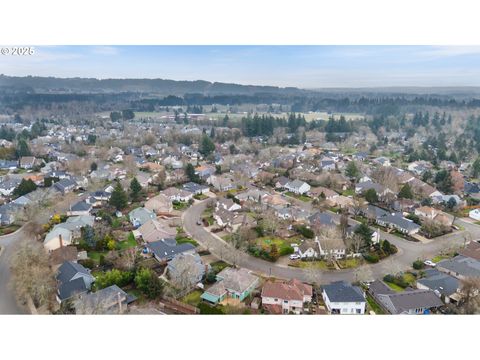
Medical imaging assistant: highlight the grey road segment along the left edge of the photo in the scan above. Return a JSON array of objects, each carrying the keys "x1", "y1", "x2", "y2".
[{"x1": 0, "y1": 229, "x2": 25, "y2": 314}]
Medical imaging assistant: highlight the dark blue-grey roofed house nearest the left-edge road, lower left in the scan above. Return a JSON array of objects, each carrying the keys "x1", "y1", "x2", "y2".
[{"x1": 56, "y1": 261, "x2": 95, "y2": 303}]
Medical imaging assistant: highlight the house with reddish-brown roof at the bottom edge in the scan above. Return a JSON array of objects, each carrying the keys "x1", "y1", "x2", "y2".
[{"x1": 262, "y1": 279, "x2": 313, "y2": 314}]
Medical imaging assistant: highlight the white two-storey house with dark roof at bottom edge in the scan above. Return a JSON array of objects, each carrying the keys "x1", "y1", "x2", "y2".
[{"x1": 322, "y1": 281, "x2": 366, "y2": 314}]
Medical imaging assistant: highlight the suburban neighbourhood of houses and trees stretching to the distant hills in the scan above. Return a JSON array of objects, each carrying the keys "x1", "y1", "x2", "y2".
[{"x1": 0, "y1": 71, "x2": 480, "y2": 315}]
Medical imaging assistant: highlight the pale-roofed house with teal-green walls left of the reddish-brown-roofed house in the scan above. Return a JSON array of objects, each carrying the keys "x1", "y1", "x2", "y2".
[{"x1": 201, "y1": 267, "x2": 259, "y2": 304}]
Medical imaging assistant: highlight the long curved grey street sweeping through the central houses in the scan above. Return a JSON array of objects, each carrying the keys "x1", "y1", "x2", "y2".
[{"x1": 182, "y1": 200, "x2": 480, "y2": 283}]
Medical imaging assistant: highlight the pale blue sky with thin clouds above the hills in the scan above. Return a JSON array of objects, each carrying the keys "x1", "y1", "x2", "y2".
[{"x1": 0, "y1": 45, "x2": 480, "y2": 88}]
